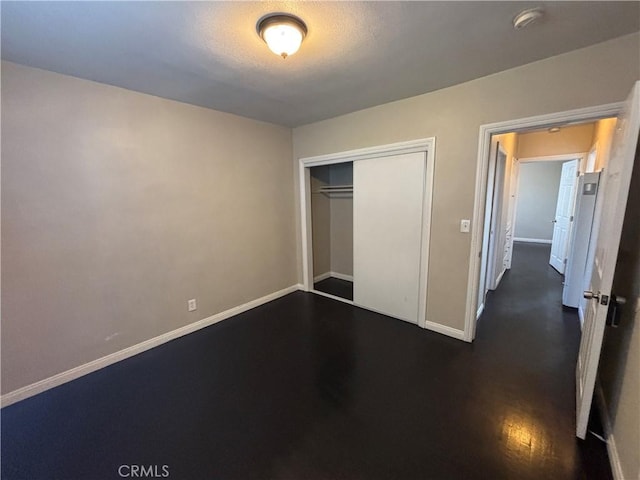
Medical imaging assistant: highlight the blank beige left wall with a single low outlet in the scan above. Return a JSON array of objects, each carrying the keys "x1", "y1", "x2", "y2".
[{"x1": 2, "y1": 62, "x2": 297, "y2": 393}]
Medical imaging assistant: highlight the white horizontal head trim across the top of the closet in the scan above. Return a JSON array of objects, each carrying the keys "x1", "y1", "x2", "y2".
[{"x1": 300, "y1": 137, "x2": 435, "y2": 168}]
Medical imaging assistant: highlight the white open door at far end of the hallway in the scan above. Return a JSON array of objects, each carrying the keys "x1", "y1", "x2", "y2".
[{"x1": 549, "y1": 160, "x2": 579, "y2": 273}]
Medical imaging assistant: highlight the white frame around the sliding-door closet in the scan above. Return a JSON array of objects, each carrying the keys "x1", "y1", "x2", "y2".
[{"x1": 298, "y1": 137, "x2": 436, "y2": 329}]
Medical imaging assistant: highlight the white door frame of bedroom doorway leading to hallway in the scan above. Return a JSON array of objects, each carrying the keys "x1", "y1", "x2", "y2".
[{"x1": 464, "y1": 102, "x2": 623, "y2": 342}]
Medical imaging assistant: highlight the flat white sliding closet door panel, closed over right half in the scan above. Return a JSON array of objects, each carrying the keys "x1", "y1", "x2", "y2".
[{"x1": 353, "y1": 152, "x2": 426, "y2": 323}]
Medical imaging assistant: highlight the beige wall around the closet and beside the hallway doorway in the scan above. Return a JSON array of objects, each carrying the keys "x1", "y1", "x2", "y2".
[{"x1": 293, "y1": 34, "x2": 640, "y2": 330}]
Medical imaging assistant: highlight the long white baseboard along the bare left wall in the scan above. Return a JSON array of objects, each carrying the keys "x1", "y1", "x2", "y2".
[{"x1": 0, "y1": 284, "x2": 304, "y2": 407}]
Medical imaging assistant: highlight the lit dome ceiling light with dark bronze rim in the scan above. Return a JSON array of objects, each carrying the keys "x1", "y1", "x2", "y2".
[{"x1": 256, "y1": 13, "x2": 307, "y2": 58}]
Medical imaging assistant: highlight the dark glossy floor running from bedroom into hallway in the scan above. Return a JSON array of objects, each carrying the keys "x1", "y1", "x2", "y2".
[{"x1": 1, "y1": 245, "x2": 611, "y2": 480}]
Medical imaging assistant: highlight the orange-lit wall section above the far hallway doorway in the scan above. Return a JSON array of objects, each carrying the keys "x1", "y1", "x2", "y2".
[{"x1": 518, "y1": 123, "x2": 595, "y2": 158}]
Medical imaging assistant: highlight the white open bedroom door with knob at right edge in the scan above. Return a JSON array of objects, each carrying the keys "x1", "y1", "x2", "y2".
[{"x1": 576, "y1": 82, "x2": 640, "y2": 438}]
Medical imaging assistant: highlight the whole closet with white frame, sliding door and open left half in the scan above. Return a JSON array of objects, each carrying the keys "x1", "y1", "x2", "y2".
[{"x1": 299, "y1": 138, "x2": 438, "y2": 329}]
